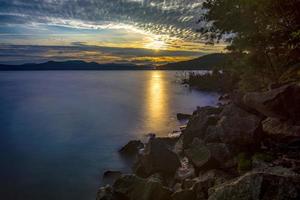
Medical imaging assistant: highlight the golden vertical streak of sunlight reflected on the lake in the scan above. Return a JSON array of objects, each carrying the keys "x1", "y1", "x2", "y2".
[{"x1": 145, "y1": 71, "x2": 168, "y2": 134}]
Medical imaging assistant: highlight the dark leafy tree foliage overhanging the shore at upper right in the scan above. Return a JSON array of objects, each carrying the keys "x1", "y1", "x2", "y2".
[{"x1": 199, "y1": 0, "x2": 300, "y2": 91}]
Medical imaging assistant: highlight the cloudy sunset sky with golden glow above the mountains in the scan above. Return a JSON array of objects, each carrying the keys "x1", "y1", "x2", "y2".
[{"x1": 0, "y1": 0, "x2": 225, "y2": 65}]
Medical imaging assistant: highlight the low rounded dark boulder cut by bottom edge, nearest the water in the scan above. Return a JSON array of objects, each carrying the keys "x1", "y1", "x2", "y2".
[{"x1": 113, "y1": 175, "x2": 172, "y2": 200}]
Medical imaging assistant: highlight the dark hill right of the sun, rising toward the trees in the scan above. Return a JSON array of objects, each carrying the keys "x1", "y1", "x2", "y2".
[{"x1": 157, "y1": 53, "x2": 228, "y2": 70}]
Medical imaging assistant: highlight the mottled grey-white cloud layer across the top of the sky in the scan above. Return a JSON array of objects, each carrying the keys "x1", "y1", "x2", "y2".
[{"x1": 0, "y1": 0, "x2": 202, "y2": 41}]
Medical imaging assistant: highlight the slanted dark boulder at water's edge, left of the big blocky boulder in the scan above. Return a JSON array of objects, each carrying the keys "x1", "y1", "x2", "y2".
[{"x1": 183, "y1": 106, "x2": 221, "y2": 147}]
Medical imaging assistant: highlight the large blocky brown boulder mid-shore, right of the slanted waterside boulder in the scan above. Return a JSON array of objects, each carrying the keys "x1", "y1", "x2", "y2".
[{"x1": 216, "y1": 104, "x2": 262, "y2": 153}]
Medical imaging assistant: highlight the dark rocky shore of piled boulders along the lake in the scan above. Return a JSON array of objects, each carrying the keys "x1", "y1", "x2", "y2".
[{"x1": 97, "y1": 84, "x2": 300, "y2": 200}]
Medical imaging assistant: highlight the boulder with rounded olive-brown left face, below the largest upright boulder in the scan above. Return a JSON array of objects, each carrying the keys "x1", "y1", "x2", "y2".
[{"x1": 184, "y1": 138, "x2": 231, "y2": 170}]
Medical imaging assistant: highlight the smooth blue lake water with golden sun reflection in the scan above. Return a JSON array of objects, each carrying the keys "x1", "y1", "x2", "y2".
[{"x1": 0, "y1": 71, "x2": 217, "y2": 200}]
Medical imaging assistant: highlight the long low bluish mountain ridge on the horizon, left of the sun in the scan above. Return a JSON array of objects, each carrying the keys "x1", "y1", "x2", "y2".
[{"x1": 0, "y1": 60, "x2": 154, "y2": 71}]
